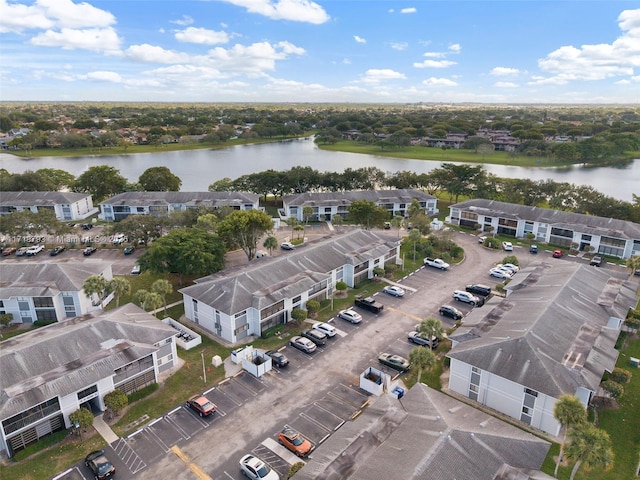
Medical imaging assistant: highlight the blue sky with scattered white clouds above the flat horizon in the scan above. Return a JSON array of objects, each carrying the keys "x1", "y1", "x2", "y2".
[{"x1": 0, "y1": 0, "x2": 640, "y2": 104}]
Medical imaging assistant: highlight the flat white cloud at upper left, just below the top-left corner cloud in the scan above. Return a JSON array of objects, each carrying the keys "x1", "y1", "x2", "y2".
[{"x1": 29, "y1": 27, "x2": 120, "y2": 55}]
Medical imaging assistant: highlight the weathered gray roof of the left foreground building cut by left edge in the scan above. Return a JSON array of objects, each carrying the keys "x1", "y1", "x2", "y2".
[{"x1": 0, "y1": 303, "x2": 176, "y2": 419}]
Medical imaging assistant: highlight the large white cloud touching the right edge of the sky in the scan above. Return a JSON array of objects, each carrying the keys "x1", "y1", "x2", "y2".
[{"x1": 535, "y1": 9, "x2": 640, "y2": 85}]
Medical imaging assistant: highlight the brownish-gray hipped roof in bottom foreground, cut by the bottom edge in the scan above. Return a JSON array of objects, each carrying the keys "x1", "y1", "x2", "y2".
[{"x1": 296, "y1": 383, "x2": 550, "y2": 480}]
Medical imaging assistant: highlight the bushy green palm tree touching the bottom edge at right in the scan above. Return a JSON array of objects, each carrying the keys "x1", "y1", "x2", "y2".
[{"x1": 566, "y1": 423, "x2": 613, "y2": 480}]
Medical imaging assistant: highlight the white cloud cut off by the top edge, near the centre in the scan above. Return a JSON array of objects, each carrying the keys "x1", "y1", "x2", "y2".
[{"x1": 222, "y1": 0, "x2": 330, "y2": 24}]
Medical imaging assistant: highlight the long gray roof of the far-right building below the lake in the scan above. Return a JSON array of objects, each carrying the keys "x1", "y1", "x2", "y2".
[{"x1": 451, "y1": 199, "x2": 640, "y2": 239}]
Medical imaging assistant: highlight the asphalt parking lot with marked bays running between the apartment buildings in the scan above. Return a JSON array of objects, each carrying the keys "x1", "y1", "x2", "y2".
[{"x1": 48, "y1": 234, "x2": 632, "y2": 479}]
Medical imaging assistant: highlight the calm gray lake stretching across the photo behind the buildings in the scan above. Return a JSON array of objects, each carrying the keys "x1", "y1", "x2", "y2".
[{"x1": 0, "y1": 139, "x2": 640, "y2": 202}]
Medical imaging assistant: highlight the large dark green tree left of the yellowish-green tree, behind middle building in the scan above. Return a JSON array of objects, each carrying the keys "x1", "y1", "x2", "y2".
[{"x1": 138, "y1": 228, "x2": 225, "y2": 284}]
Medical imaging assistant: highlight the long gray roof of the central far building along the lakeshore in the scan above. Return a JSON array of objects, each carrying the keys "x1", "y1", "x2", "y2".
[{"x1": 282, "y1": 189, "x2": 436, "y2": 207}]
